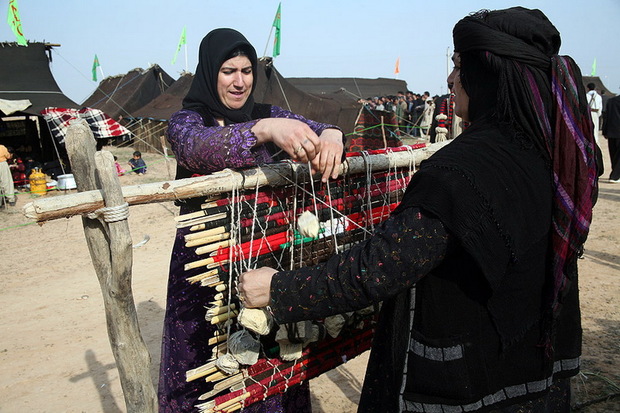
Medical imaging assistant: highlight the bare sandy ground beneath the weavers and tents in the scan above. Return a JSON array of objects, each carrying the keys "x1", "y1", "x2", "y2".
[{"x1": 0, "y1": 140, "x2": 620, "y2": 413}]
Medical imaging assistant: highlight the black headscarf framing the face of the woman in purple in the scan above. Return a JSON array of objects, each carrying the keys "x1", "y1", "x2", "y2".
[{"x1": 183, "y1": 29, "x2": 257, "y2": 125}]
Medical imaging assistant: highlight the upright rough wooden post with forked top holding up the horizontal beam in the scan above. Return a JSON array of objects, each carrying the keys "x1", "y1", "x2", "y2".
[{"x1": 65, "y1": 120, "x2": 157, "y2": 413}]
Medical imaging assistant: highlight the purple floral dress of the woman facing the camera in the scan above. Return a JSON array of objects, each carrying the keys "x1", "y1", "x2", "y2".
[{"x1": 158, "y1": 106, "x2": 334, "y2": 413}]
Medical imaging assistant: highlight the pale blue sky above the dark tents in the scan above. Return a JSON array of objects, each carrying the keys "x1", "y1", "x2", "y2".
[{"x1": 6, "y1": 0, "x2": 620, "y2": 103}]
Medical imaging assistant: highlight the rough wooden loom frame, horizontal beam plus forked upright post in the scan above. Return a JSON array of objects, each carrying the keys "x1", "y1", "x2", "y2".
[{"x1": 23, "y1": 120, "x2": 448, "y2": 413}]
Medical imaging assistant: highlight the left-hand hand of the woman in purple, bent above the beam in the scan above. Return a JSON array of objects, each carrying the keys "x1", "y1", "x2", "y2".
[{"x1": 252, "y1": 118, "x2": 323, "y2": 163}]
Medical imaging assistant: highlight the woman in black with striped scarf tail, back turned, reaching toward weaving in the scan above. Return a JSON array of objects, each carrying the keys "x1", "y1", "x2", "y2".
[{"x1": 238, "y1": 7, "x2": 598, "y2": 413}]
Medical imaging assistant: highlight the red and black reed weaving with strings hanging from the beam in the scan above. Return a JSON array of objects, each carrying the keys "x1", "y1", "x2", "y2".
[{"x1": 177, "y1": 144, "x2": 426, "y2": 412}]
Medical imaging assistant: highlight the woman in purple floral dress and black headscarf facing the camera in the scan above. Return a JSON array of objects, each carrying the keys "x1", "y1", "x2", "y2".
[{"x1": 158, "y1": 29, "x2": 344, "y2": 412}]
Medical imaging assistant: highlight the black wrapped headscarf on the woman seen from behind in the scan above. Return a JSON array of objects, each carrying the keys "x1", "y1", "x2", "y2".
[{"x1": 453, "y1": 7, "x2": 561, "y2": 153}]
